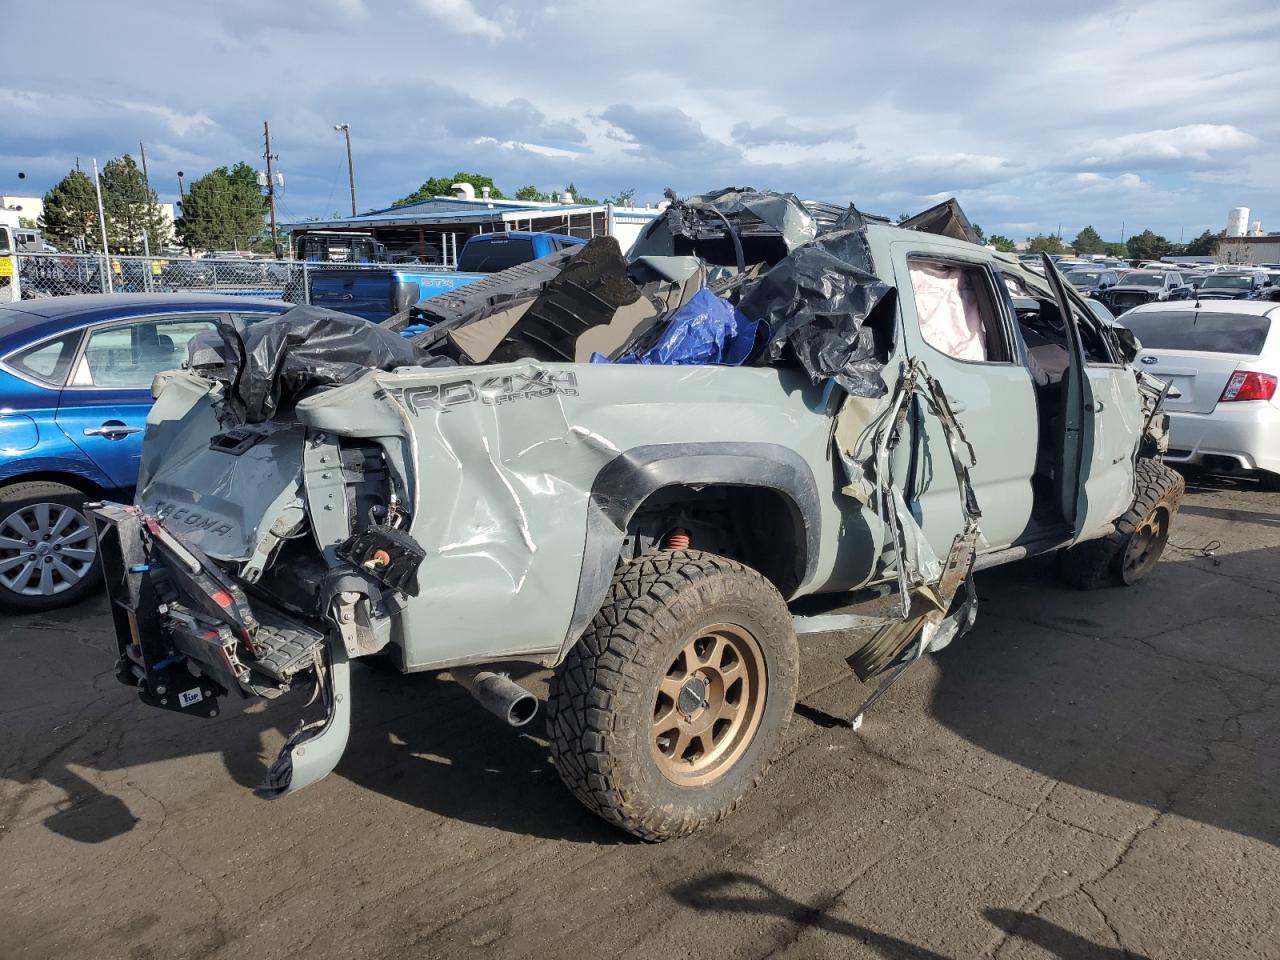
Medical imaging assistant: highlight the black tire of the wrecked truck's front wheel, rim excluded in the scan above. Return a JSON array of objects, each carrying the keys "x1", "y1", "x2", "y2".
[{"x1": 1059, "y1": 460, "x2": 1185, "y2": 590}]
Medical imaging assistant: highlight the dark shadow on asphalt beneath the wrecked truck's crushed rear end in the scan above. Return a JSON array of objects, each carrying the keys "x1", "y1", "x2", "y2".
[{"x1": 0, "y1": 602, "x2": 616, "y2": 844}]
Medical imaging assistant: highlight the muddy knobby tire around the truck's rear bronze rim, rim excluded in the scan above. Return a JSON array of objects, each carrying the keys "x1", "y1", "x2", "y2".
[{"x1": 547, "y1": 550, "x2": 800, "y2": 841}]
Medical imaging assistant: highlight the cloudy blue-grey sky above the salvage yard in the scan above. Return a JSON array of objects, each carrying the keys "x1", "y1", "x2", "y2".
[{"x1": 0, "y1": 0, "x2": 1280, "y2": 241}]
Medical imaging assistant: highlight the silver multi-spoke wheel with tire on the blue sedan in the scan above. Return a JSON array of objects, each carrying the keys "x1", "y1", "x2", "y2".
[{"x1": 0, "y1": 480, "x2": 102, "y2": 611}]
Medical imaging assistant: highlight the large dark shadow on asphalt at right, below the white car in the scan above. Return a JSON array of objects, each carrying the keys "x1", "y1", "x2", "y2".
[{"x1": 932, "y1": 550, "x2": 1280, "y2": 845}]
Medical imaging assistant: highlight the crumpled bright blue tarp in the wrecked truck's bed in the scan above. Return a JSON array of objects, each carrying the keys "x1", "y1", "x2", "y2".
[{"x1": 591, "y1": 288, "x2": 760, "y2": 366}]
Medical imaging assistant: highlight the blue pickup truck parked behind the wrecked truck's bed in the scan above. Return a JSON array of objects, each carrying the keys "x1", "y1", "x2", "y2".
[{"x1": 311, "y1": 232, "x2": 586, "y2": 323}]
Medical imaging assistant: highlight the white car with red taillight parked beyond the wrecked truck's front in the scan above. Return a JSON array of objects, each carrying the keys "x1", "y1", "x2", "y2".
[{"x1": 1119, "y1": 300, "x2": 1280, "y2": 489}]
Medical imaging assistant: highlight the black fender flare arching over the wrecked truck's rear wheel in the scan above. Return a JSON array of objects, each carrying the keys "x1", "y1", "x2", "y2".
[{"x1": 556, "y1": 442, "x2": 822, "y2": 663}]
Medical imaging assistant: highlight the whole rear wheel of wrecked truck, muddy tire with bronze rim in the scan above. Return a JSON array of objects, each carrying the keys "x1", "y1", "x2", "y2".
[{"x1": 547, "y1": 550, "x2": 799, "y2": 840}]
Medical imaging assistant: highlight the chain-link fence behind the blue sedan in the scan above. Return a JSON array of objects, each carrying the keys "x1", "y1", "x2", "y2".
[{"x1": 7, "y1": 253, "x2": 412, "y2": 303}]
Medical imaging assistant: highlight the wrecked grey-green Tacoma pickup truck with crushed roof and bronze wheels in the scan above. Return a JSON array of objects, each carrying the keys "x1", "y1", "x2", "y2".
[{"x1": 95, "y1": 189, "x2": 1183, "y2": 840}]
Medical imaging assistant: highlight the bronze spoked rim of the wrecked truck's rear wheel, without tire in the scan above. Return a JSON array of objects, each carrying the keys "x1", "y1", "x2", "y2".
[{"x1": 649, "y1": 623, "x2": 765, "y2": 786}]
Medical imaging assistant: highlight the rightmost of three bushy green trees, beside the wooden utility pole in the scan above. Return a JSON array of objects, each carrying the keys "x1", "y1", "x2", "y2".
[{"x1": 175, "y1": 163, "x2": 270, "y2": 251}]
